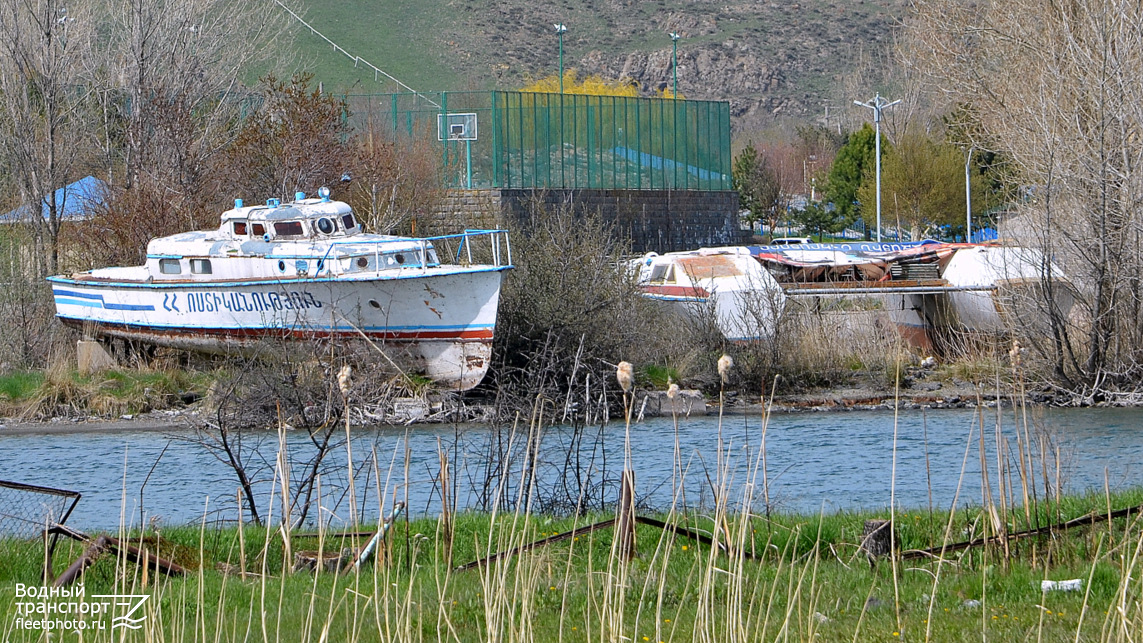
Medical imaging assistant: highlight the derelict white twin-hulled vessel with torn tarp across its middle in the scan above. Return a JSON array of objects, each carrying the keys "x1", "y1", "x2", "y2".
[{"x1": 640, "y1": 240, "x2": 1073, "y2": 349}]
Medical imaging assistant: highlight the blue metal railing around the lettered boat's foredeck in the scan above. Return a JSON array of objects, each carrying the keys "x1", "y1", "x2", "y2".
[{"x1": 318, "y1": 230, "x2": 512, "y2": 273}]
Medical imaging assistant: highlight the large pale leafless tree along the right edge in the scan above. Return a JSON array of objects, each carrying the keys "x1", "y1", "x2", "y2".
[{"x1": 906, "y1": 0, "x2": 1143, "y2": 400}]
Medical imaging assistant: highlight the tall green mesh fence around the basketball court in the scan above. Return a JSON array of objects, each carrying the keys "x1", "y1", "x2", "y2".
[{"x1": 349, "y1": 91, "x2": 732, "y2": 190}]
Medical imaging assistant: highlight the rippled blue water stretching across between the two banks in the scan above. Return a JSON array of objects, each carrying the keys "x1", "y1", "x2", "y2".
[{"x1": 0, "y1": 409, "x2": 1143, "y2": 530}]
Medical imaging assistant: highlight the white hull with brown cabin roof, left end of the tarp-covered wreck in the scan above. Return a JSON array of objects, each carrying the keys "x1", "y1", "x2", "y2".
[{"x1": 632, "y1": 247, "x2": 785, "y2": 341}]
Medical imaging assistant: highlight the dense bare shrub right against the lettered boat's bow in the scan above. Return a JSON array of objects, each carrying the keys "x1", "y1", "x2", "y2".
[{"x1": 489, "y1": 200, "x2": 662, "y2": 418}]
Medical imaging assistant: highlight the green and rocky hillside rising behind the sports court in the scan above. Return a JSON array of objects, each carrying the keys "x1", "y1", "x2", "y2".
[{"x1": 283, "y1": 0, "x2": 905, "y2": 129}]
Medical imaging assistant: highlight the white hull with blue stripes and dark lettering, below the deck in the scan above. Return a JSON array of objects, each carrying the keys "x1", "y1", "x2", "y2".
[{"x1": 50, "y1": 266, "x2": 506, "y2": 391}]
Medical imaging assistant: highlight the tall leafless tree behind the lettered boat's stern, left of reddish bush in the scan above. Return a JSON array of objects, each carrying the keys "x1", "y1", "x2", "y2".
[{"x1": 93, "y1": 0, "x2": 281, "y2": 194}]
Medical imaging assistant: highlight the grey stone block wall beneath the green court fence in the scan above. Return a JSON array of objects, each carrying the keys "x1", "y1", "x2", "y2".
[{"x1": 429, "y1": 190, "x2": 750, "y2": 254}]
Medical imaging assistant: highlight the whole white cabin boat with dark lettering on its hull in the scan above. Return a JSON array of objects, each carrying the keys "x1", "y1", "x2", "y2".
[{"x1": 48, "y1": 188, "x2": 512, "y2": 391}]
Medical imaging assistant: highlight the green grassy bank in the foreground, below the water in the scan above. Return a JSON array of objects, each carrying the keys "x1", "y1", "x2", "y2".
[{"x1": 0, "y1": 490, "x2": 1143, "y2": 643}]
